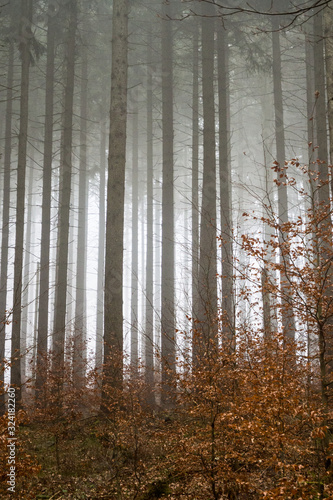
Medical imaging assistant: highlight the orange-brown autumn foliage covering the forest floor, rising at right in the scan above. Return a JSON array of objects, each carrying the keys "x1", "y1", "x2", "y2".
[{"x1": 5, "y1": 160, "x2": 333, "y2": 500}]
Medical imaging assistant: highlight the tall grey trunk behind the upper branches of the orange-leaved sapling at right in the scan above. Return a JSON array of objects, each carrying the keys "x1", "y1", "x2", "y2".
[{"x1": 272, "y1": 16, "x2": 295, "y2": 340}]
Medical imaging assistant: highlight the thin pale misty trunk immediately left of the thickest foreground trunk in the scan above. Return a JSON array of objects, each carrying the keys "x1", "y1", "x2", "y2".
[{"x1": 96, "y1": 117, "x2": 106, "y2": 372}]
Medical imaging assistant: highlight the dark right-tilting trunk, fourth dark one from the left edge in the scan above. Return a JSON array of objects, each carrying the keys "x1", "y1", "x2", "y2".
[{"x1": 53, "y1": 0, "x2": 77, "y2": 386}]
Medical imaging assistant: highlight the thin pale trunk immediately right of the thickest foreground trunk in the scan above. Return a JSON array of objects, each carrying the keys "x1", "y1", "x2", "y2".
[{"x1": 131, "y1": 90, "x2": 139, "y2": 371}]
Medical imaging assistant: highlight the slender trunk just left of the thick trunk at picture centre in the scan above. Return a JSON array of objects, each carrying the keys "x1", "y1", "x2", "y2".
[{"x1": 144, "y1": 29, "x2": 154, "y2": 394}]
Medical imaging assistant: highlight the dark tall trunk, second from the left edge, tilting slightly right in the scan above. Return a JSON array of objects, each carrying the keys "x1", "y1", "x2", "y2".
[{"x1": 10, "y1": 0, "x2": 32, "y2": 407}]
